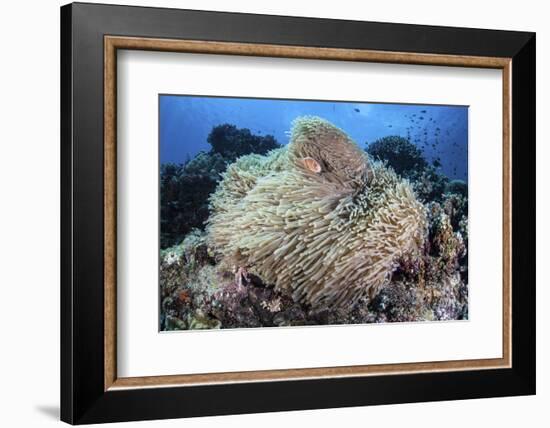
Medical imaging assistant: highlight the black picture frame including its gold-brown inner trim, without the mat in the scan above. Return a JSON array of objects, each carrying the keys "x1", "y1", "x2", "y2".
[{"x1": 61, "y1": 3, "x2": 536, "y2": 424}]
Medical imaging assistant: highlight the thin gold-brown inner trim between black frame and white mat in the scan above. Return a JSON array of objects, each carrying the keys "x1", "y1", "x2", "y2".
[{"x1": 104, "y1": 36, "x2": 512, "y2": 391}]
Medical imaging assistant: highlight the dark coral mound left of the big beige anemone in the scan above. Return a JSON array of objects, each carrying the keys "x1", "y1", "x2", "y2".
[{"x1": 160, "y1": 124, "x2": 280, "y2": 248}]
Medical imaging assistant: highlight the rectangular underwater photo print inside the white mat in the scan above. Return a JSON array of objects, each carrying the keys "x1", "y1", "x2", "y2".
[{"x1": 159, "y1": 94, "x2": 468, "y2": 331}]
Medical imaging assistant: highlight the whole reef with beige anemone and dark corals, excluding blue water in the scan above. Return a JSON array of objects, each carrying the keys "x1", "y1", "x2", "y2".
[{"x1": 160, "y1": 118, "x2": 468, "y2": 330}]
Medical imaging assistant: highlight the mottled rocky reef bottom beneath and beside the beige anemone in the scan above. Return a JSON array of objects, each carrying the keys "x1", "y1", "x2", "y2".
[{"x1": 161, "y1": 203, "x2": 468, "y2": 330}]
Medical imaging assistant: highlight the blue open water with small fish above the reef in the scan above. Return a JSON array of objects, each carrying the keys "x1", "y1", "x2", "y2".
[{"x1": 159, "y1": 95, "x2": 468, "y2": 180}]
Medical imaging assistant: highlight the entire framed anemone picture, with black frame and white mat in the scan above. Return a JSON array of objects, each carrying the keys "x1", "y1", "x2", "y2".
[{"x1": 61, "y1": 3, "x2": 535, "y2": 424}]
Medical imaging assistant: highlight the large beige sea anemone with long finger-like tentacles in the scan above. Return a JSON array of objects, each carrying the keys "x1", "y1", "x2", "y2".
[{"x1": 207, "y1": 117, "x2": 427, "y2": 308}]
